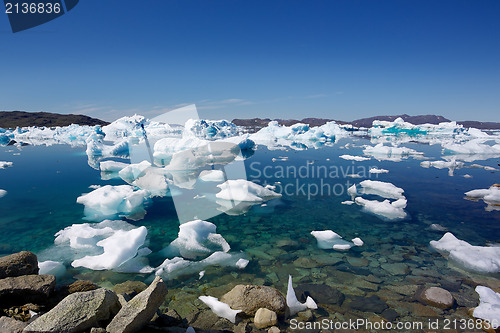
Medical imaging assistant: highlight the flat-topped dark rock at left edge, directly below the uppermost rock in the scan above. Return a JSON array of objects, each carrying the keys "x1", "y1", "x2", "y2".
[{"x1": 0, "y1": 275, "x2": 56, "y2": 305}]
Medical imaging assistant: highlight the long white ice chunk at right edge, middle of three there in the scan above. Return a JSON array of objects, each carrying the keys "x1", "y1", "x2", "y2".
[{"x1": 430, "y1": 232, "x2": 500, "y2": 273}]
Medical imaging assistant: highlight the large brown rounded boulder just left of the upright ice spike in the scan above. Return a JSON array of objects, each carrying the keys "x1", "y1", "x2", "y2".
[{"x1": 221, "y1": 284, "x2": 286, "y2": 316}]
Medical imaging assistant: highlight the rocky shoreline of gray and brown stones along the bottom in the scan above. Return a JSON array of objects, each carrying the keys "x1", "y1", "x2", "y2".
[{"x1": 0, "y1": 251, "x2": 495, "y2": 333}]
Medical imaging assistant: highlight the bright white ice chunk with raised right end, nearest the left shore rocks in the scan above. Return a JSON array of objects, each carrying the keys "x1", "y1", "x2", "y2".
[{"x1": 71, "y1": 226, "x2": 148, "y2": 270}]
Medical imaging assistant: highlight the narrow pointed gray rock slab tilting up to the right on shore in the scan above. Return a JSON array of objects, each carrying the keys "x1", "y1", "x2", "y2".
[{"x1": 106, "y1": 276, "x2": 167, "y2": 333}]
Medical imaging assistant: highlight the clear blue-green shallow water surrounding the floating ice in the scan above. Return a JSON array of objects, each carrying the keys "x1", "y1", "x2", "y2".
[{"x1": 0, "y1": 139, "x2": 500, "y2": 330}]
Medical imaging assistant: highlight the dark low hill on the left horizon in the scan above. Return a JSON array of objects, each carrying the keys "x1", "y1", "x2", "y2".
[{"x1": 0, "y1": 111, "x2": 109, "y2": 128}]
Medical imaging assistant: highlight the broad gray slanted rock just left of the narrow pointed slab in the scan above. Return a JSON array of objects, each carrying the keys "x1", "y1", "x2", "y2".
[{"x1": 23, "y1": 288, "x2": 120, "y2": 333}]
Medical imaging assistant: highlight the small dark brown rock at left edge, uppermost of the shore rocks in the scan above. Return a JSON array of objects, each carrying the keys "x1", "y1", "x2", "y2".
[{"x1": 0, "y1": 251, "x2": 38, "y2": 279}]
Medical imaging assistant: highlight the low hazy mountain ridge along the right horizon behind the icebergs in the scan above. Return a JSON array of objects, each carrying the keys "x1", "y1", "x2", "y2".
[{"x1": 233, "y1": 114, "x2": 500, "y2": 131}]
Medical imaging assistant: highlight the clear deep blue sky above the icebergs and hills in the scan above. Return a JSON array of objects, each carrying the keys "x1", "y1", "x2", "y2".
[{"x1": 0, "y1": 0, "x2": 500, "y2": 121}]
